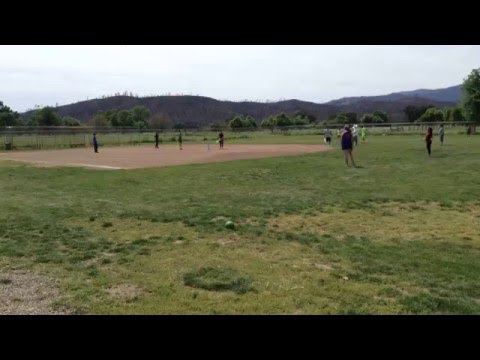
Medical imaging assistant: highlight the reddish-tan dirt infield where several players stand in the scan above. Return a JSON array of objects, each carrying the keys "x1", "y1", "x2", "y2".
[{"x1": 0, "y1": 144, "x2": 332, "y2": 170}]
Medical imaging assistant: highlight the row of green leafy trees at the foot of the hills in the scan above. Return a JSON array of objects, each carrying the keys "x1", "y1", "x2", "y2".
[{"x1": 0, "y1": 69, "x2": 480, "y2": 129}]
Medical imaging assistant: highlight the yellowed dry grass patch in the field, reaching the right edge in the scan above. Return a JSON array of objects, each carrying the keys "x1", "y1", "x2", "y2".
[{"x1": 267, "y1": 202, "x2": 480, "y2": 245}]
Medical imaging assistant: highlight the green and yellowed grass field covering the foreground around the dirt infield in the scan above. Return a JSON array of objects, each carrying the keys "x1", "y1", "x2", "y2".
[{"x1": 0, "y1": 134, "x2": 480, "y2": 314}]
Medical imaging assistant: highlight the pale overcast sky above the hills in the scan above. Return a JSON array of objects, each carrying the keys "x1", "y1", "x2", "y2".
[{"x1": 0, "y1": 45, "x2": 480, "y2": 112}]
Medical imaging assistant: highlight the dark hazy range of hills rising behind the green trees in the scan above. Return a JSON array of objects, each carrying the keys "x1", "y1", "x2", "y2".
[{"x1": 23, "y1": 85, "x2": 461, "y2": 126}]
